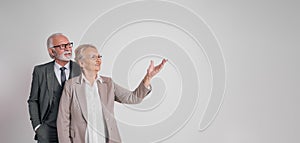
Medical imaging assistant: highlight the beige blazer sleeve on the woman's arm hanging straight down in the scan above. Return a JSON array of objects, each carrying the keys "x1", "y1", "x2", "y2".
[{"x1": 56, "y1": 82, "x2": 72, "y2": 143}]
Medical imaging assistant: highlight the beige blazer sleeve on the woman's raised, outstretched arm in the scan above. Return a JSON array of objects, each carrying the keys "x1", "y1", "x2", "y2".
[{"x1": 113, "y1": 82, "x2": 152, "y2": 104}]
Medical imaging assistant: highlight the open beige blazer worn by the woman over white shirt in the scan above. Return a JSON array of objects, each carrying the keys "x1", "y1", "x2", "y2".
[{"x1": 57, "y1": 75, "x2": 151, "y2": 143}]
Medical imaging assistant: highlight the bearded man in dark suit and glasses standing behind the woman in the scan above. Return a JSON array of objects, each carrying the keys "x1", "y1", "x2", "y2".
[{"x1": 27, "y1": 33, "x2": 81, "y2": 143}]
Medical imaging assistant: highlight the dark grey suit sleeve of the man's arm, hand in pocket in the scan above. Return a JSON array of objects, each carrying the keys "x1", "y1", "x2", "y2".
[{"x1": 27, "y1": 67, "x2": 41, "y2": 129}]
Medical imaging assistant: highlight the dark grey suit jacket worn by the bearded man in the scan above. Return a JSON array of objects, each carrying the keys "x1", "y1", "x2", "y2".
[{"x1": 27, "y1": 61, "x2": 81, "y2": 140}]
